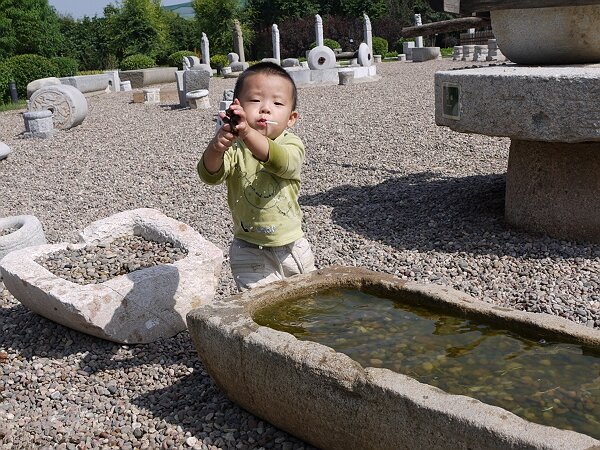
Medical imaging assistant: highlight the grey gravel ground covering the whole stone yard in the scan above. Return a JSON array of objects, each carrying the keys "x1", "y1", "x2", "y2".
[{"x1": 0, "y1": 60, "x2": 600, "y2": 450}]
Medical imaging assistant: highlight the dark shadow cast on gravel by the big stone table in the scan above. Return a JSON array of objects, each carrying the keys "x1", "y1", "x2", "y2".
[{"x1": 300, "y1": 172, "x2": 590, "y2": 258}]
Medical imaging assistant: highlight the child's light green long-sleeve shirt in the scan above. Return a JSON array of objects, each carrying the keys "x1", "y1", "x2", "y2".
[{"x1": 198, "y1": 131, "x2": 304, "y2": 247}]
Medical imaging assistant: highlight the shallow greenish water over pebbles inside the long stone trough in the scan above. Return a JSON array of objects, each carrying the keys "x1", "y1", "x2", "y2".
[{"x1": 254, "y1": 290, "x2": 600, "y2": 438}]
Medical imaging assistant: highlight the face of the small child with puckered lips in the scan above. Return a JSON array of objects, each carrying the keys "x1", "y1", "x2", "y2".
[{"x1": 239, "y1": 73, "x2": 298, "y2": 139}]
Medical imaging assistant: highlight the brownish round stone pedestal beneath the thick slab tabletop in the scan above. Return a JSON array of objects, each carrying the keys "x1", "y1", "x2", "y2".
[{"x1": 505, "y1": 140, "x2": 600, "y2": 243}]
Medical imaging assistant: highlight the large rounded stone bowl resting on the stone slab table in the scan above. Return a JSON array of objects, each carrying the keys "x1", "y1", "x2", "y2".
[{"x1": 490, "y1": 5, "x2": 600, "y2": 65}]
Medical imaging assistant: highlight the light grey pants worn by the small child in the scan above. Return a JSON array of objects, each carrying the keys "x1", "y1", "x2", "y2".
[{"x1": 229, "y1": 237, "x2": 315, "y2": 291}]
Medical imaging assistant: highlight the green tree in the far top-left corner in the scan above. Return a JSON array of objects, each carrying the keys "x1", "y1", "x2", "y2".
[{"x1": 0, "y1": 0, "x2": 62, "y2": 58}]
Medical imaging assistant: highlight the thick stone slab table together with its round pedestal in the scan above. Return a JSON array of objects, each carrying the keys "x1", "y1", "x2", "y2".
[{"x1": 435, "y1": 64, "x2": 600, "y2": 242}]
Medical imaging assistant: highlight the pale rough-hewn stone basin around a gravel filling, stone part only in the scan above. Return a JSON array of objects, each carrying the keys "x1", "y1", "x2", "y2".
[{"x1": 0, "y1": 208, "x2": 223, "y2": 343}]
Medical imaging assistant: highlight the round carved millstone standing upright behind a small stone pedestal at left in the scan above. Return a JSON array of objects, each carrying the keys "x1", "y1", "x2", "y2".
[{"x1": 29, "y1": 85, "x2": 88, "y2": 130}]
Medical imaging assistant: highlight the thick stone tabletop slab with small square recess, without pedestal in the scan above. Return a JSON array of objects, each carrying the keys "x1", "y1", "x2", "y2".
[{"x1": 435, "y1": 65, "x2": 600, "y2": 143}]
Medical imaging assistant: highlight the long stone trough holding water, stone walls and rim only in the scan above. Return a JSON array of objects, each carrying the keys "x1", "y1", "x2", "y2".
[{"x1": 188, "y1": 267, "x2": 600, "y2": 450}]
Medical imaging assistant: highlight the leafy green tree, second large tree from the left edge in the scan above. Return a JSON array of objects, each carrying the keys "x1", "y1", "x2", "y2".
[{"x1": 105, "y1": 0, "x2": 167, "y2": 59}]
